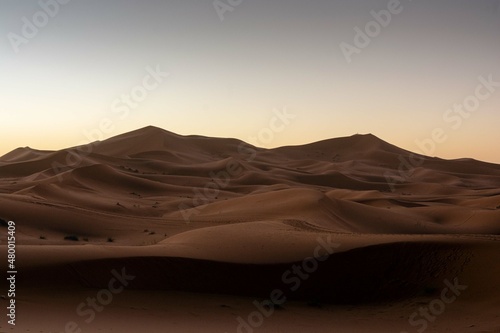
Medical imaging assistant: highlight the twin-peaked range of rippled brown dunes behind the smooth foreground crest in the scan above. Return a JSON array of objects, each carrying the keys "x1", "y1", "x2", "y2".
[{"x1": 0, "y1": 127, "x2": 500, "y2": 236}]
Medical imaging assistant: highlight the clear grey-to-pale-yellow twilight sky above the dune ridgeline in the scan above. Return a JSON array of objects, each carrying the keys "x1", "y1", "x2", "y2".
[{"x1": 0, "y1": 0, "x2": 500, "y2": 163}]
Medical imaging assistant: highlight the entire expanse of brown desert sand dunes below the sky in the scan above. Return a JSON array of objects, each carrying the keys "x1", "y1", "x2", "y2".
[{"x1": 0, "y1": 127, "x2": 500, "y2": 333}]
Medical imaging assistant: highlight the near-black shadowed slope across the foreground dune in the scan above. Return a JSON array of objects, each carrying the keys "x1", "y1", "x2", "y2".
[{"x1": 14, "y1": 237, "x2": 500, "y2": 304}]
